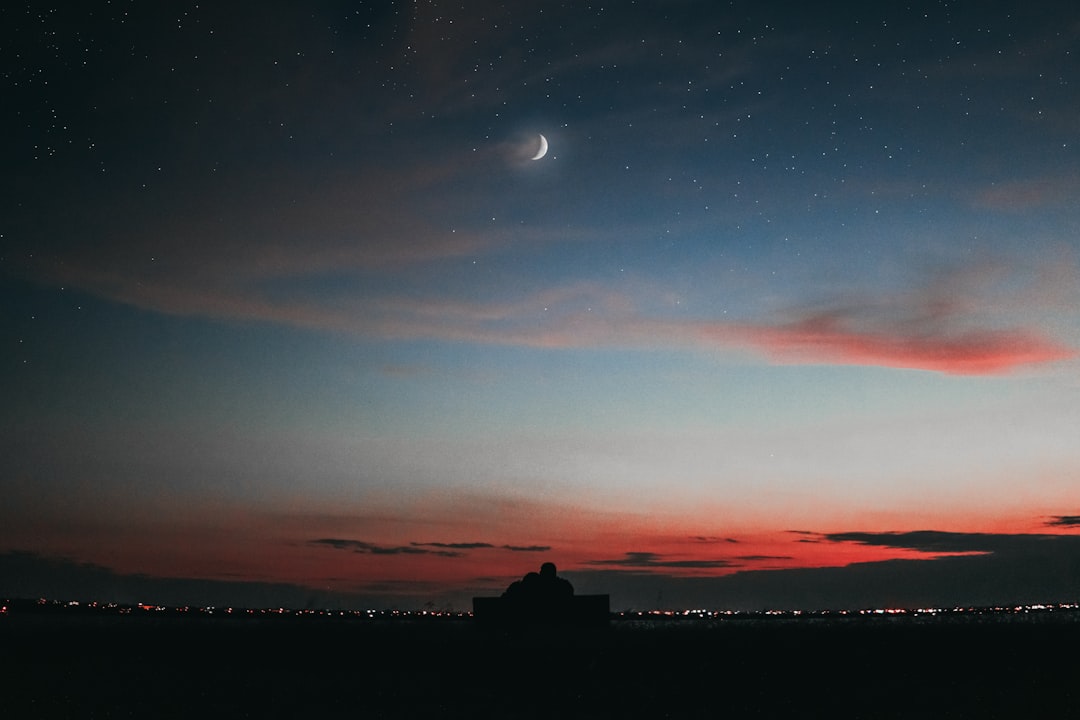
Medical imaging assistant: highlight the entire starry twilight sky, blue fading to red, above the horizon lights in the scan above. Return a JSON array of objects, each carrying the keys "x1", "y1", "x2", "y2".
[{"x1": 0, "y1": 0, "x2": 1080, "y2": 609}]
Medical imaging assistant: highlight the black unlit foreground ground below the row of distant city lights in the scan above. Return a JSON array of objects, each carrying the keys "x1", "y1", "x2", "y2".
[{"x1": 0, "y1": 617, "x2": 1080, "y2": 719}]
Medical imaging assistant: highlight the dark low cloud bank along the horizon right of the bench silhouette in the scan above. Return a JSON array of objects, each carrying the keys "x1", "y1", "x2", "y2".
[{"x1": 564, "y1": 531, "x2": 1080, "y2": 610}]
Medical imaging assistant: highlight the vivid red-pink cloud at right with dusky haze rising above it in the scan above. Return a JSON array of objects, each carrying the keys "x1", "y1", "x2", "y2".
[{"x1": 702, "y1": 256, "x2": 1077, "y2": 376}]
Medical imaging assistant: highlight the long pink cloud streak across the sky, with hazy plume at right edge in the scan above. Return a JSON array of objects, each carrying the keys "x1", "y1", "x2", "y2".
[{"x1": 35, "y1": 239, "x2": 1077, "y2": 376}]
